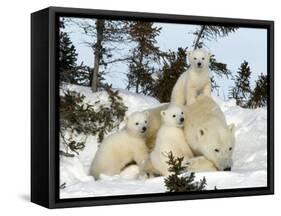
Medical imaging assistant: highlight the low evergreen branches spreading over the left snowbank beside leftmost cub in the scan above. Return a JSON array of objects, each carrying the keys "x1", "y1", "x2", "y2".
[{"x1": 60, "y1": 88, "x2": 127, "y2": 156}]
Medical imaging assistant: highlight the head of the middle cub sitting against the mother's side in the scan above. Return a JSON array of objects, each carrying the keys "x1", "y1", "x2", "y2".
[{"x1": 161, "y1": 104, "x2": 184, "y2": 127}]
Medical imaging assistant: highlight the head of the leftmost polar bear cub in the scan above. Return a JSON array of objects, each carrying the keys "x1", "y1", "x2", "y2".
[{"x1": 124, "y1": 111, "x2": 149, "y2": 136}]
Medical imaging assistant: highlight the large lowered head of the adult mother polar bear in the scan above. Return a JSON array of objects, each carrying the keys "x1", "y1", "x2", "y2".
[{"x1": 196, "y1": 124, "x2": 235, "y2": 171}]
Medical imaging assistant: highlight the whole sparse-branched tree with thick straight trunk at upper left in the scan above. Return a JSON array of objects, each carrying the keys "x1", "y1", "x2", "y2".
[{"x1": 72, "y1": 18, "x2": 128, "y2": 92}]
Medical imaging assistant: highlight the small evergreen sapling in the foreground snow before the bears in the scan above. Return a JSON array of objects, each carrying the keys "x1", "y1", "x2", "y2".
[{"x1": 164, "y1": 152, "x2": 207, "y2": 192}]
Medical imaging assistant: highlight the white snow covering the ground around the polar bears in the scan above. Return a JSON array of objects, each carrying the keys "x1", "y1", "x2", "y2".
[{"x1": 60, "y1": 85, "x2": 267, "y2": 198}]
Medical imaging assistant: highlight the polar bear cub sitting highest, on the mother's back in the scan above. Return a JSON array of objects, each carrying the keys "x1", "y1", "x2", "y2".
[{"x1": 171, "y1": 49, "x2": 211, "y2": 105}]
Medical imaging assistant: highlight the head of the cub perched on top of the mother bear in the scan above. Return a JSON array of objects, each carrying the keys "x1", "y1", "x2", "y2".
[{"x1": 187, "y1": 49, "x2": 212, "y2": 70}]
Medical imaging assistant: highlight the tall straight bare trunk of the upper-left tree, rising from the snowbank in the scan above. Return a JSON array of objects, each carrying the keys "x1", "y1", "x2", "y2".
[{"x1": 91, "y1": 19, "x2": 104, "y2": 92}]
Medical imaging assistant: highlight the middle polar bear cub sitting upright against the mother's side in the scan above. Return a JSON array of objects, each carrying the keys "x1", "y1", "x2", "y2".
[{"x1": 150, "y1": 104, "x2": 193, "y2": 176}]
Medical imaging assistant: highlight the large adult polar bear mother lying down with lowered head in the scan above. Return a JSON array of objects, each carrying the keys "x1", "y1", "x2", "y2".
[{"x1": 144, "y1": 95, "x2": 235, "y2": 171}]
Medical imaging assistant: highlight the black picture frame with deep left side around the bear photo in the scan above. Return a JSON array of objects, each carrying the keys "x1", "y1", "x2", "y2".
[{"x1": 31, "y1": 7, "x2": 274, "y2": 208}]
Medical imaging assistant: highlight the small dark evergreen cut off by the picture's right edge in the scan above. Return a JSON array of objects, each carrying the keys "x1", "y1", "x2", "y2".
[{"x1": 247, "y1": 74, "x2": 268, "y2": 108}]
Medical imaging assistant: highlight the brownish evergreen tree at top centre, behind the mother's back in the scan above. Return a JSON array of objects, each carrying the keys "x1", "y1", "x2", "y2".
[{"x1": 127, "y1": 21, "x2": 161, "y2": 94}]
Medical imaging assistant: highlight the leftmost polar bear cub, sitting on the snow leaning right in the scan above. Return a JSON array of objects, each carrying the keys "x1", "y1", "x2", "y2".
[{"x1": 90, "y1": 112, "x2": 149, "y2": 179}]
